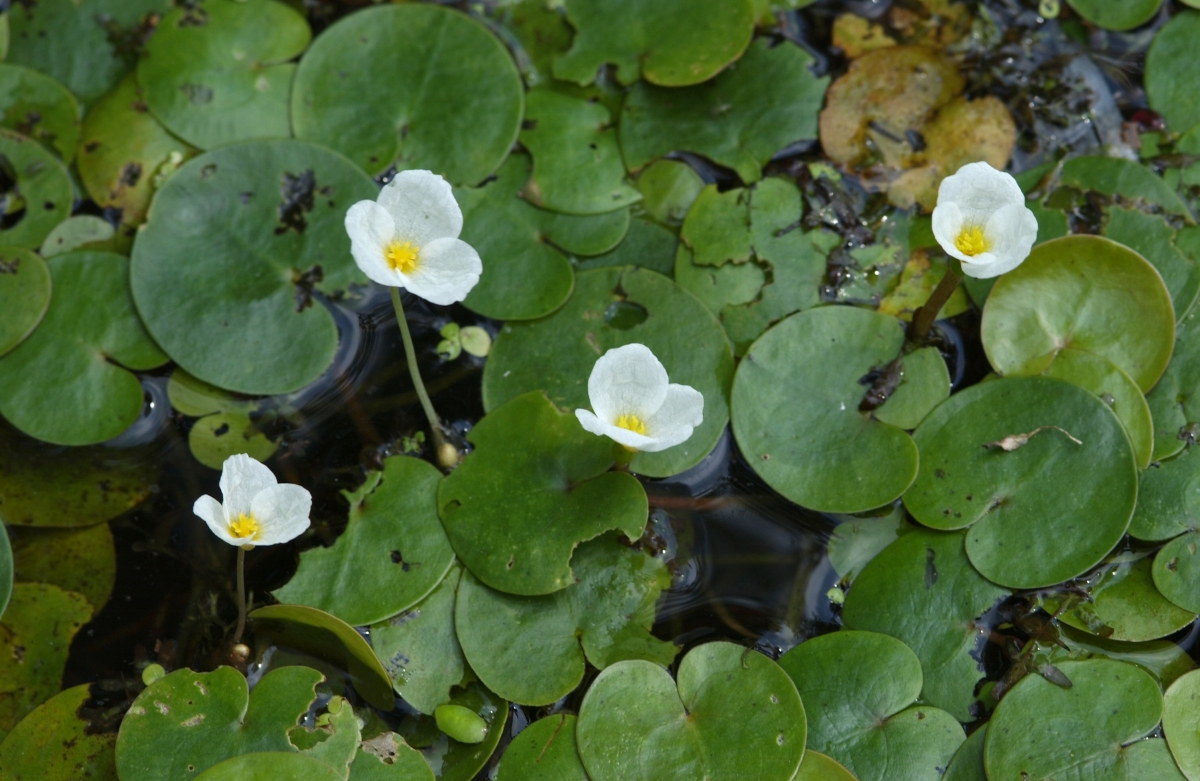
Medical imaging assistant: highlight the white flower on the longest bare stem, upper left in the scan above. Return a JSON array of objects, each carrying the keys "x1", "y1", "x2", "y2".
[{"x1": 346, "y1": 170, "x2": 484, "y2": 305}]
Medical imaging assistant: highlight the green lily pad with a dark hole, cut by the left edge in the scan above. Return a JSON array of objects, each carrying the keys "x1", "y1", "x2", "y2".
[{"x1": 0, "y1": 128, "x2": 74, "y2": 250}]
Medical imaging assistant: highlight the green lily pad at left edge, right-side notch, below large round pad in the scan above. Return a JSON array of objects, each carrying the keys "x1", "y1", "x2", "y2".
[{"x1": 0, "y1": 252, "x2": 167, "y2": 445}]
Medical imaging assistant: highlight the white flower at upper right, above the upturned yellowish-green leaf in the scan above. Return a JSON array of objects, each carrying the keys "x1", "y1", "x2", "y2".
[{"x1": 934, "y1": 163, "x2": 1038, "y2": 280}]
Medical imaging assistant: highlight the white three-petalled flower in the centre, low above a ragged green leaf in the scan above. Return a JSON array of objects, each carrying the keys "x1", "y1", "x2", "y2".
[{"x1": 575, "y1": 344, "x2": 704, "y2": 452}]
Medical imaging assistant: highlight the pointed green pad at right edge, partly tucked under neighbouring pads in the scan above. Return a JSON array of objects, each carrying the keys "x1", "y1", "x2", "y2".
[{"x1": 1054, "y1": 557, "x2": 1196, "y2": 642}]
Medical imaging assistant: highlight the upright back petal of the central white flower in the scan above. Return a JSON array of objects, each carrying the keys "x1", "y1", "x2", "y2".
[{"x1": 588, "y1": 344, "x2": 667, "y2": 424}]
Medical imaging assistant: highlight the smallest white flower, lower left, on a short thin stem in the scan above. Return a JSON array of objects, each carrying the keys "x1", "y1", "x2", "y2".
[{"x1": 192, "y1": 453, "x2": 312, "y2": 548}]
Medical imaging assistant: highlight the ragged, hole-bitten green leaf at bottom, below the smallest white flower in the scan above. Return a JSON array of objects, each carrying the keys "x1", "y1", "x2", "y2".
[{"x1": 116, "y1": 667, "x2": 324, "y2": 781}]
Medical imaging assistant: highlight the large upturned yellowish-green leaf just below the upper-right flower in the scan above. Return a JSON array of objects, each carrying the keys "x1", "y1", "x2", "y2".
[{"x1": 979, "y1": 236, "x2": 1175, "y2": 391}]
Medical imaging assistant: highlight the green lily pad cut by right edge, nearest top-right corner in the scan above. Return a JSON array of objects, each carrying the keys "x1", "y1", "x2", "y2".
[{"x1": 1144, "y1": 12, "x2": 1200, "y2": 133}]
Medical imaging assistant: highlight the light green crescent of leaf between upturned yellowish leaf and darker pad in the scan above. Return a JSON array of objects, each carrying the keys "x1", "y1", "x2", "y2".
[{"x1": 1043, "y1": 348, "x2": 1154, "y2": 469}]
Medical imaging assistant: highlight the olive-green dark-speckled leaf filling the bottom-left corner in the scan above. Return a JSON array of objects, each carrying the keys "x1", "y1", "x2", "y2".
[{"x1": 0, "y1": 684, "x2": 116, "y2": 781}]
